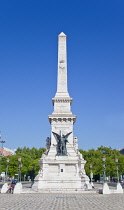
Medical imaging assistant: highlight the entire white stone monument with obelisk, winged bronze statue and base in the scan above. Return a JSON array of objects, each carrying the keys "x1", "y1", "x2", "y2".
[{"x1": 32, "y1": 32, "x2": 89, "y2": 191}]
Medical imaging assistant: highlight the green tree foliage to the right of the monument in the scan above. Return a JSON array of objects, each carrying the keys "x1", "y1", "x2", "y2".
[{"x1": 79, "y1": 146, "x2": 124, "y2": 179}]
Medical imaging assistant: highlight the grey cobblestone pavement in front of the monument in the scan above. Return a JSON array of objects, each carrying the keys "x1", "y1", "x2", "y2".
[{"x1": 0, "y1": 193, "x2": 124, "y2": 210}]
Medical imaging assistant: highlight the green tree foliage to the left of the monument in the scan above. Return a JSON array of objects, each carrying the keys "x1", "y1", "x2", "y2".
[{"x1": 1, "y1": 147, "x2": 45, "y2": 179}]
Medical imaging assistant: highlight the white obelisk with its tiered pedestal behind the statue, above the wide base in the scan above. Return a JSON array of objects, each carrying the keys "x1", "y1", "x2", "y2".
[{"x1": 48, "y1": 32, "x2": 76, "y2": 155}]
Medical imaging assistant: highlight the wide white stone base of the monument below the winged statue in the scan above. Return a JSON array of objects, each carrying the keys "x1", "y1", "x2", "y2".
[{"x1": 32, "y1": 153, "x2": 95, "y2": 192}]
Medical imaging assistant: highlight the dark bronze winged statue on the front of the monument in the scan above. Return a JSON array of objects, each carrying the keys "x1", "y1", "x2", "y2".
[{"x1": 52, "y1": 131, "x2": 72, "y2": 156}]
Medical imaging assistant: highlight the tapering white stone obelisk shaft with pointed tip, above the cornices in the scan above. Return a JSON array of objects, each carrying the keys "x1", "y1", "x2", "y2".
[{"x1": 55, "y1": 32, "x2": 69, "y2": 97}]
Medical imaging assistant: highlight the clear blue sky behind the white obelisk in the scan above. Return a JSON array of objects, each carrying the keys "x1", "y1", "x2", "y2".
[{"x1": 0, "y1": 0, "x2": 124, "y2": 150}]
